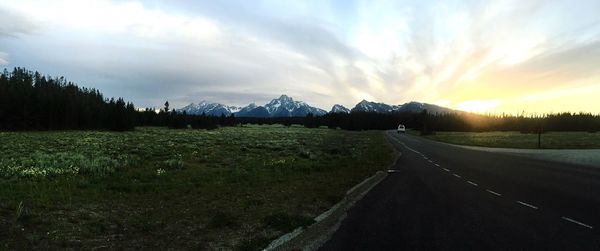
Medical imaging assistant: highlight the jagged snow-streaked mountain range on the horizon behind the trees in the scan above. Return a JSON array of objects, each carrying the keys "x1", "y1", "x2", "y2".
[{"x1": 176, "y1": 95, "x2": 458, "y2": 118}]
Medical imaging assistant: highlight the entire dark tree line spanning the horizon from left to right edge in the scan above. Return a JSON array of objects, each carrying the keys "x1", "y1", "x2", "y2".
[{"x1": 0, "y1": 68, "x2": 600, "y2": 134}]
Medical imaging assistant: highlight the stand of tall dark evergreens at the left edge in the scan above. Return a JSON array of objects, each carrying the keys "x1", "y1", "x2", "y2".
[{"x1": 0, "y1": 68, "x2": 136, "y2": 131}]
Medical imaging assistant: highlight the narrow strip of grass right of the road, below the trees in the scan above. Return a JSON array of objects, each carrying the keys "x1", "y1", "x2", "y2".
[{"x1": 409, "y1": 131, "x2": 600, "y2": 149}]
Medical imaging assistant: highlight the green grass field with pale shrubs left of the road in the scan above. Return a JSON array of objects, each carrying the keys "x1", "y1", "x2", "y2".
[{"x1": 0, "y1": 126, "x2": 392, "y2": 250}]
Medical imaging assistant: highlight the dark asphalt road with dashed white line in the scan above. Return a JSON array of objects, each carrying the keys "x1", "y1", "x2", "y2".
[{"x1": 320, "y1": 131, "x2": 600, "y2": 250}]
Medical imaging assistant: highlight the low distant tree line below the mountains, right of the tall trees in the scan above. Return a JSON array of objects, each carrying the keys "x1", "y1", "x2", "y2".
[{"x1": 162, "y1": 110, "x2": 600, "y2": 134}]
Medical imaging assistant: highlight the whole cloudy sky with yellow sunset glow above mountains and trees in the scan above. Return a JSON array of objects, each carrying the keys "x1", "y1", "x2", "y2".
[{"x1": 0, "y1": 0, "x2": 600, "y2": 114}]
